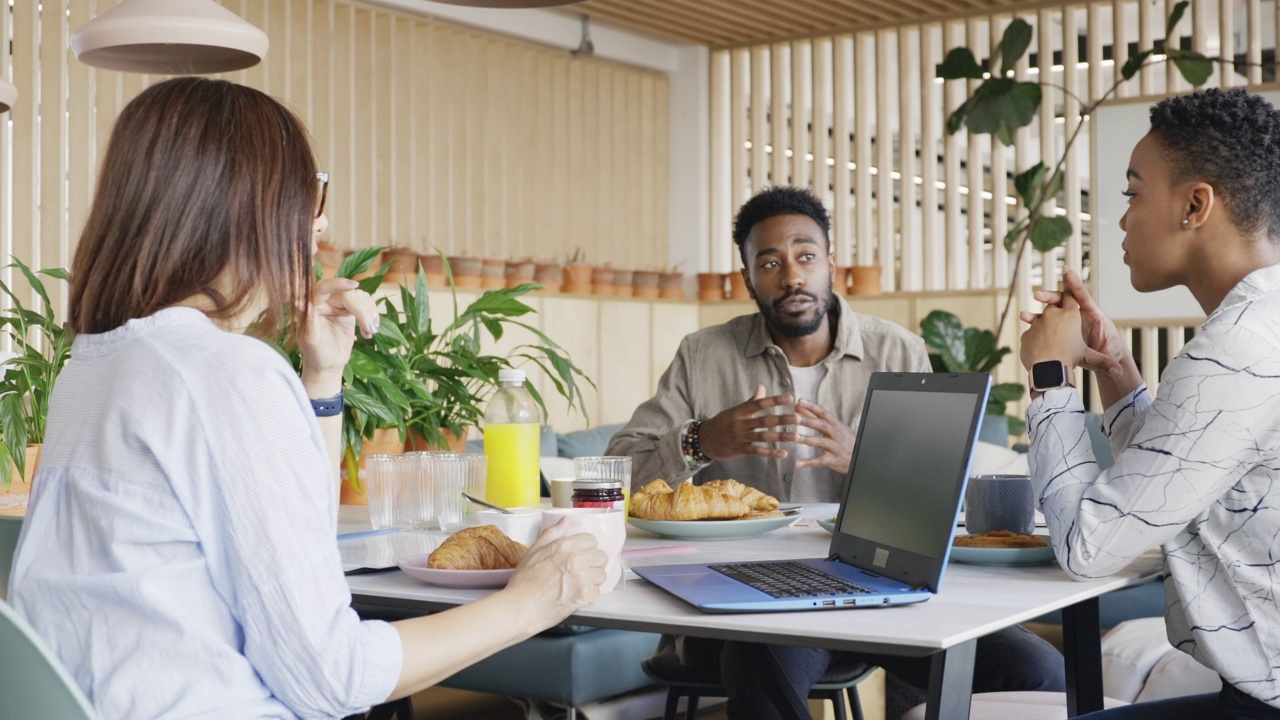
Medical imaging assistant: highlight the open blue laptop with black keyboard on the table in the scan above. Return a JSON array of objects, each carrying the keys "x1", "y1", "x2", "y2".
[{"x1": 634, "y1": 373, "x2": 991, "y2": 612}]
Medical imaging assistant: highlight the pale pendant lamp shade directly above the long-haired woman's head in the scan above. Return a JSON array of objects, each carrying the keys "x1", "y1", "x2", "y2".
[{"x1": 72, "y1": 0, "x2": 269, "y2": 74}]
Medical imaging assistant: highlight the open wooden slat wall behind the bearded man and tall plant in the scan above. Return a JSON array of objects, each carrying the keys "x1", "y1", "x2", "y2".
[{"x1": 708, "y1": 0, "x2": 1259, "y2": 404}]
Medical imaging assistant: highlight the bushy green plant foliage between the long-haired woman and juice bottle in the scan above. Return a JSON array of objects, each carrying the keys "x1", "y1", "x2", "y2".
[{"x1": 283, "y1": 247, "x2": 590, "y2": 486}]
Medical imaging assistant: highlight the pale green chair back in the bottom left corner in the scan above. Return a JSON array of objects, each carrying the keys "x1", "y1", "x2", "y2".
[{"x1": 0, "y1": 601, "x2": 96, "y2": 720}]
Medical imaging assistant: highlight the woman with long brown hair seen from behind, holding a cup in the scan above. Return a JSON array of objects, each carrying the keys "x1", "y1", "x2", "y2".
[{"x1": 9, "y1": 78, "x2": 604, "y2": 720}]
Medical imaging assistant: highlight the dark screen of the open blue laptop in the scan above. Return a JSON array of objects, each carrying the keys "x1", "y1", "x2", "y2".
[{"x1": 832, "y1": 373, "x2": 989, "y2": 587}]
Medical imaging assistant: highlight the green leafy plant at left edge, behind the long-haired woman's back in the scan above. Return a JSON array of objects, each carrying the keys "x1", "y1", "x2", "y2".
[{"x1": 0, "y1": 258, "x2": 72, "y2": 489}]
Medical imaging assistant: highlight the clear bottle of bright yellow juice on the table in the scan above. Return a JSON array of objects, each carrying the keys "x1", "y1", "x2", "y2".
[{"x1": 484, "y1": 369, "x2": 541, "y2": 507}]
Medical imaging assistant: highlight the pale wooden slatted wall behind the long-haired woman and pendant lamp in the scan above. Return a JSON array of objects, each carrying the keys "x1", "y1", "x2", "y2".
[{"x1": 0, "y1": 0, "x2": 668, "y2": 330}]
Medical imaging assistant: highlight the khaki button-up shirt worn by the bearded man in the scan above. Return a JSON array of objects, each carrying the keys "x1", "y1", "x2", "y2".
[{"x1": 607, "y1": 296, "x2": 931, "y2": 502}]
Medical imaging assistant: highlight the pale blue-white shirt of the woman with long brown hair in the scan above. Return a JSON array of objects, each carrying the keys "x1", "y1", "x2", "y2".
[{"x1": 9, "y1": 307, "x2": 401, "y2": 720}]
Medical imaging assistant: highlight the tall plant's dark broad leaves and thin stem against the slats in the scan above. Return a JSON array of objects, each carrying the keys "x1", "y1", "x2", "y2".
[{"x1": 938, "y1": 0, "x2": 1208, "y2": 333}]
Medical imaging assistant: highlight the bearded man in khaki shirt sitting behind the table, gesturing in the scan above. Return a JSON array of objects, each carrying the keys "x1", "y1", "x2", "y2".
[{"x1": 608, "y1": 187, "x2": 1065, "y2": 717}]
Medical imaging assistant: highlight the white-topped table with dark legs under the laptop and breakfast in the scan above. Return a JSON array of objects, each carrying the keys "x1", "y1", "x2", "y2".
[{"x1": 343, "y1": 505, "x2": 1160, "y2": 720}]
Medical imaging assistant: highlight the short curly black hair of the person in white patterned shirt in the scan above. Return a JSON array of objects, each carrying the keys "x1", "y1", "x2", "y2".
[{"x1": 1151, "y1": 88, "x2": 1280, "y2": 237}]
